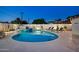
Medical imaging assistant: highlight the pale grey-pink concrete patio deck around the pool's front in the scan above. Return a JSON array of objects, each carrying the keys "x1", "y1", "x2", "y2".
[{"x1": 0, "y1": 31, "x2": 75, "y2": 52}]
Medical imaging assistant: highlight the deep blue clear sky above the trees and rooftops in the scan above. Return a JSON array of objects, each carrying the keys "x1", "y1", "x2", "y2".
[{"x1": 0, "y1": 6, "x2": 79, "y2": 23}]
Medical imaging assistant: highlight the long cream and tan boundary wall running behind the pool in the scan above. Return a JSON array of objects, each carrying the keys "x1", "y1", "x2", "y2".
[{"x1": 0, "y1": 23, "x2": 72, "y2": 32}]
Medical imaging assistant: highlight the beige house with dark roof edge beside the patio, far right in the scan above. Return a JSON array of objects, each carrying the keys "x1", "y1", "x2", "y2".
[{"x1": 67, "y1": 15, "x2": 79, "y2": 35}]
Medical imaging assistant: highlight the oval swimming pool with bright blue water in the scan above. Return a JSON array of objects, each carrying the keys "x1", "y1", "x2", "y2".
[{"x1": 12, "y1": 30, "x2": 58, "y2": 42}]
